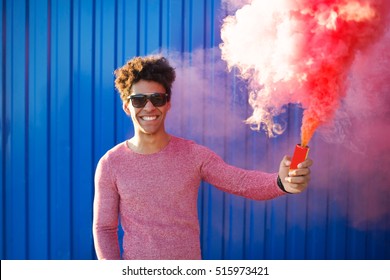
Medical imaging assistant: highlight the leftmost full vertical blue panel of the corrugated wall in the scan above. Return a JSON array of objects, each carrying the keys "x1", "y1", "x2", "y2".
[{"x1": 4, "y1": 1, "x2": 28, "y2": 259}]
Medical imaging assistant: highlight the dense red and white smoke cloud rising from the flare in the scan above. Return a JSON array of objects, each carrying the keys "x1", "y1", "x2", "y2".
[{"x1": 220, "y1": 0, "x2": 388, "y2": 145}]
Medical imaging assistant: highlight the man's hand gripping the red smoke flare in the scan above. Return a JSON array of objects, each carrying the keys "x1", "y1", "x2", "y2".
[{"x1": 279, "y1": 156, "x2": 313, "y2": 193}]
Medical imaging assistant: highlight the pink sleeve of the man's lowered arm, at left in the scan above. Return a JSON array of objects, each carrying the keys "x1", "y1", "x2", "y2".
[{"x1": 93, "y1": 154, "x2": 120, "y2": 260}]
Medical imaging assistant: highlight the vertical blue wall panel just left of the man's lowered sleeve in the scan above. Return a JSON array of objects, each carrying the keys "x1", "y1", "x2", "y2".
[{"x1": 71, "y1": 0, "x2": 94, "y2": 259}]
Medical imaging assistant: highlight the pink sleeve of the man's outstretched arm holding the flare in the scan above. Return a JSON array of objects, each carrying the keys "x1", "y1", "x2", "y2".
[{"x1": 200, "y1": 148, "x2": 285, "y2": 200}]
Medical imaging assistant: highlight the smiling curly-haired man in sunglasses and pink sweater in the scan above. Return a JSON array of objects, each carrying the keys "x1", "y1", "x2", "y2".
[{"x1": 93, "y1": 56, "x2": 312, "y2": 259}]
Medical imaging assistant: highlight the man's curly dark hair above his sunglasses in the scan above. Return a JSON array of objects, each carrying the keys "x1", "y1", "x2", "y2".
[{"x1": 114, "y1": 55, "x2": 176, "y2": 102}]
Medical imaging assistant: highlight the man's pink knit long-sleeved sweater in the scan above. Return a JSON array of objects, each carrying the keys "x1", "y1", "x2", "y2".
[{"x1": 93, "y1": 137, "x2": 284, "y2": 259}]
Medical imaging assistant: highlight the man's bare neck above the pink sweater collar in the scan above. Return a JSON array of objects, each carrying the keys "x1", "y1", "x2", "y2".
[{"x1": 128, "y1": 133, "x2": 171, "y2": 154}]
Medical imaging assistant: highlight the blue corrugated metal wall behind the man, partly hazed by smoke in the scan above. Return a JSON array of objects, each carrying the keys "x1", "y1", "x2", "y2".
[{"x1": 0, "y1": 0, "x2": 390, "y2": 259}]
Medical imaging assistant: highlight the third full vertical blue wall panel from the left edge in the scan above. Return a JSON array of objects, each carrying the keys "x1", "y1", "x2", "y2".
[{"x1": 49, "y1": 1, "x2": 73, "y2": 259}]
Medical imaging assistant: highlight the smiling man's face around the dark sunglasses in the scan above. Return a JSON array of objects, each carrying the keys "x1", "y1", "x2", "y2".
[{"x1": 123, "y1": 80, "x2": 171, "y2": 135}]
